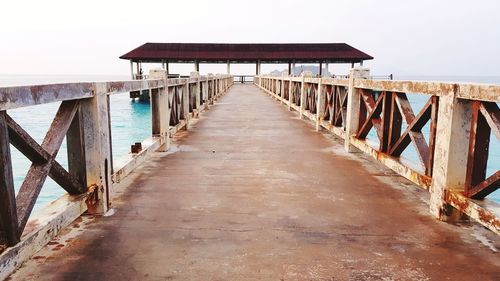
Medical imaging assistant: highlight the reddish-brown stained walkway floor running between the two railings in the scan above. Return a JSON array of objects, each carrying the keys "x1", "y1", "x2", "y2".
[{"x1": 11, "y1": 85, "x2": 500, "y2": 281}]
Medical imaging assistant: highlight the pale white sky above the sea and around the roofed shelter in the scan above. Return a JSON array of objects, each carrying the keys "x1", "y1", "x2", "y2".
[{"x1": 0, "y1": 0, "x2": 500, "y2": 76}]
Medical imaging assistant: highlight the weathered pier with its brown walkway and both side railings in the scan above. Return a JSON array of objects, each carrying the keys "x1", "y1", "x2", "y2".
[{"x1": 0, "y1": 44, "x2": 500, "y2": 280}]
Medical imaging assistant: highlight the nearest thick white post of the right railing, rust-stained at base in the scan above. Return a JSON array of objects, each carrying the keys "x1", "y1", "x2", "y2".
[{"x1": 429, "y1": 88, "x2": 472, "y2": 221}]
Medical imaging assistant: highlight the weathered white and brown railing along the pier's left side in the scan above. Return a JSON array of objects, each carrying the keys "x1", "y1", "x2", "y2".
[{"x1": 0, "y1": 70, "x2": 233, "y2": 250}]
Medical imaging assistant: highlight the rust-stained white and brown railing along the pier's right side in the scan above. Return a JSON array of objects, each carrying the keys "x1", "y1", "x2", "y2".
[{"x1": 254, "y1": 69, "x2": 500, "y2": 234}]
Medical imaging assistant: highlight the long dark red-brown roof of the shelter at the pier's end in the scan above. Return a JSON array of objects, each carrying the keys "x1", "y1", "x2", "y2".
[{"x1": 120, "y1": 43, "x2": 373, "y2": 63}]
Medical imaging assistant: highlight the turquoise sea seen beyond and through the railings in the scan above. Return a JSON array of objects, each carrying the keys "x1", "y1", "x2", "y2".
[{"x1": 0, "y1": 74, "x2": 500, "y2": 212}]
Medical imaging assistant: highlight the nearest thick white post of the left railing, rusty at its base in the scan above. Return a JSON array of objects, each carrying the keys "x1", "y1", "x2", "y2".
[{"x1": 80, "y1": 83, "x2": 113, "y2": 214}]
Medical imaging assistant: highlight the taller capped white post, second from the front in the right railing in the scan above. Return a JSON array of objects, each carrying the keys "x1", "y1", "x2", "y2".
[{"x1": 344, "y1": 68, "x2": 370, "y2": 152}]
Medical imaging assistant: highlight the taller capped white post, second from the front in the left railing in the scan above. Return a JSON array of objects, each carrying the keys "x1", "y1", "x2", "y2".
[{"x1": 149, "y1": 70, "x2": 170, "y2": 151}]
